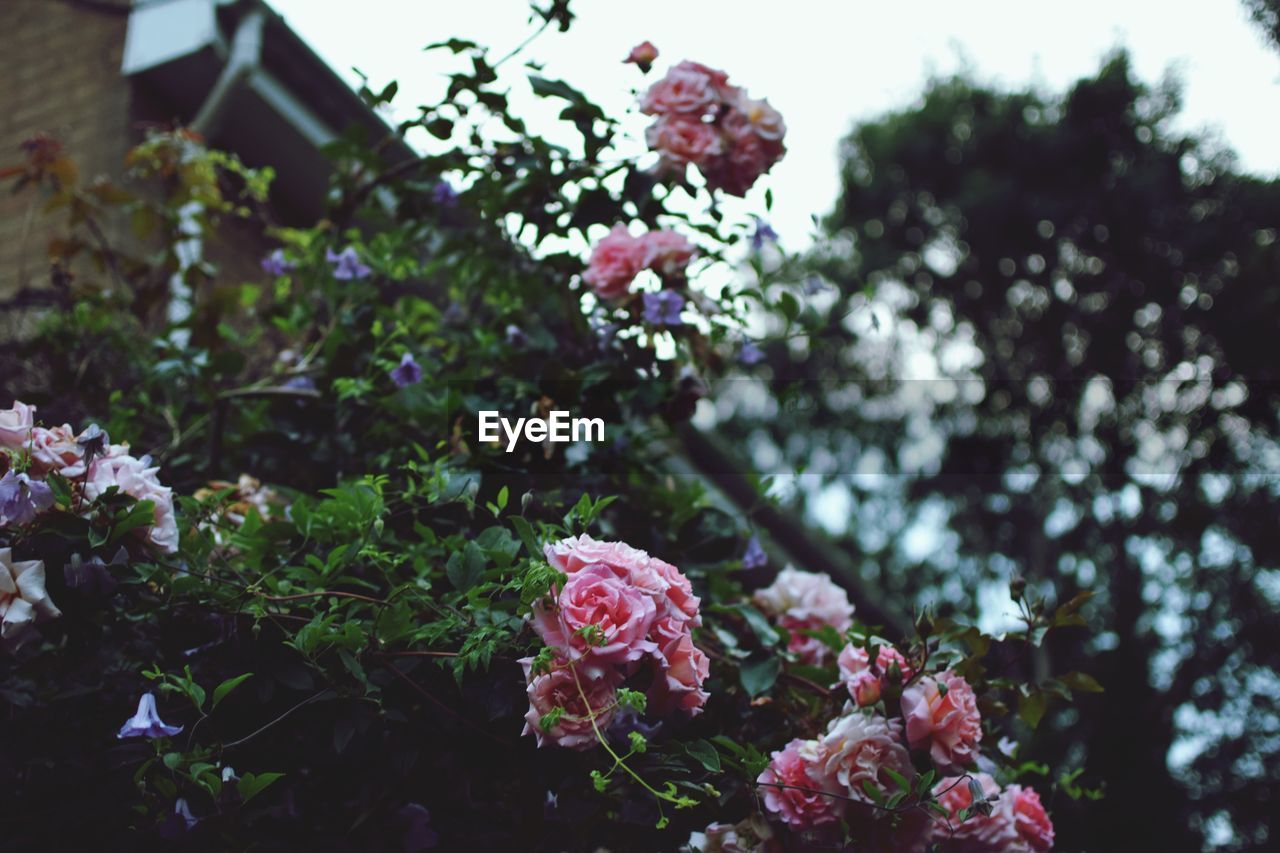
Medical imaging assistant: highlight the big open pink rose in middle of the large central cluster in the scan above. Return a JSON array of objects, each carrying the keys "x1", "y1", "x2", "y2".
[{"x1": 534, "y1": 564, "x2": 658, "y2": 676}]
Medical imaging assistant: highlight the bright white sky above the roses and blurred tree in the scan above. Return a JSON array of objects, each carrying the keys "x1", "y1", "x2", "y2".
[{"x1": 269, "y1": 0, "x2": 1280, "y2": 250}]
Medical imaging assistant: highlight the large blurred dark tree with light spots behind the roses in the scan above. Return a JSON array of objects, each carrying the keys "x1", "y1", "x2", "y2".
[{"x1": 721, "y1": 55, "x2": 1280, "y2": 850}]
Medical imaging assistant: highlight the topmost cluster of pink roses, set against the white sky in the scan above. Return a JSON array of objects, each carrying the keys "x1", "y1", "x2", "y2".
[{"x1": 640, "y1": 61, "x2": 787, "y2": 196}]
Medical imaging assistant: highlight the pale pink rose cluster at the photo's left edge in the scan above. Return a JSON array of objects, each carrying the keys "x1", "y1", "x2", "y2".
[{"x1": 0, "y1": 402, "x2": 178, "y2": 553}]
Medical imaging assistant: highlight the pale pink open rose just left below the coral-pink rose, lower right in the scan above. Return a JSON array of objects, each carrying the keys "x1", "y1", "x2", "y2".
[{"x1": 818, "y1": 711, "x2": 915, "y2": 803}]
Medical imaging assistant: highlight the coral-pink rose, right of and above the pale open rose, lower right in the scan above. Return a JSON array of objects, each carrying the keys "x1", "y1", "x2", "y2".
[{"x1": 902, "y1": 671, "x2": 982, "y2": 772}]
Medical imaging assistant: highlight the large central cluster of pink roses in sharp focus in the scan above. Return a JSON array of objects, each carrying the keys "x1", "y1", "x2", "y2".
[{"x1": 521, "y1": 535, "x2": 709, "y2": 749}]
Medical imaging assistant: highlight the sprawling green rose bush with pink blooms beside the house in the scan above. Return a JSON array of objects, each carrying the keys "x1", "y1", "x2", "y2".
[{"x1": 0, "y1": 3, "x2": 1096, "y2": 850}]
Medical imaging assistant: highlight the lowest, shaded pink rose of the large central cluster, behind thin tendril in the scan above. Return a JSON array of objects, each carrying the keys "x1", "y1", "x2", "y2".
[{"x1": 520, "y1": 657, "x2": 618, "y2": 749}]
